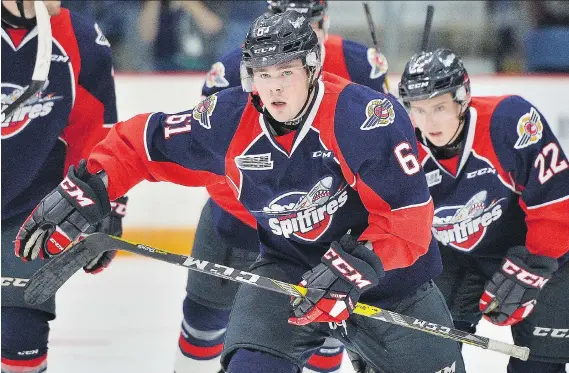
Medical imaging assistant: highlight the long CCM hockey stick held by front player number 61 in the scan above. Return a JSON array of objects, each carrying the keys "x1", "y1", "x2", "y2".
[{"x1": 24, "y1": 233, "x2": 529, "y2": 360}]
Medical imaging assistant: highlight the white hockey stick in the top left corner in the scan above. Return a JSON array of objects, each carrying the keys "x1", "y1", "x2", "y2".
[{"x1": 2, "y1": 1, "x2": 52, "y2": 122}]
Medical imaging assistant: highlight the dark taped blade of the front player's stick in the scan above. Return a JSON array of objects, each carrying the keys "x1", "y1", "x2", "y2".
[{"x1": 24, "y1": 235, "x2": 110, "y2": 305}]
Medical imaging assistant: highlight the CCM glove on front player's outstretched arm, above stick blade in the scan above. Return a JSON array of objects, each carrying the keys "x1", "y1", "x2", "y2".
[{"x1": 15, "y1": 160, "x2": 110, "y2": 261}]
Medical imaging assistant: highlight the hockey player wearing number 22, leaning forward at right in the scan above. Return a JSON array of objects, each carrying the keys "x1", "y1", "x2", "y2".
[{"x1": 399, "y1": 49, "x2": 569, "y2": 373}]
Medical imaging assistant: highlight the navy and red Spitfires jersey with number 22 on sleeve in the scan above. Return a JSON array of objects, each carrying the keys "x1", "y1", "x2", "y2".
[{"x1": 420, "y1": 96, "x2": 569, "y2": 264}]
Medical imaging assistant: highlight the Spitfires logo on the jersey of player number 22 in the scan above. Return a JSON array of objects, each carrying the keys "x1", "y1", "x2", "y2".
[{"x1": 431, "y1": 190, "x2": 504, "y2": 251}]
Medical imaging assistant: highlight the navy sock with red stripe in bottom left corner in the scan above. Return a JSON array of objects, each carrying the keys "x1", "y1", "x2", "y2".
[{"x1": 2, "y1": 307, "x2": 53, "y2": 373}]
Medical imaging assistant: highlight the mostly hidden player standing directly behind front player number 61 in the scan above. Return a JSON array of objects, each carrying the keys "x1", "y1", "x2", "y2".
[{"x1": 179, "y1": 0, "x2": 388, "y2": 373}]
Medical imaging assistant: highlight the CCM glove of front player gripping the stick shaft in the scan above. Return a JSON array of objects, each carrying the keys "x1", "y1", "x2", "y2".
[{"x1": 288, "y1": 235, "x2": 384, "y2": 325}]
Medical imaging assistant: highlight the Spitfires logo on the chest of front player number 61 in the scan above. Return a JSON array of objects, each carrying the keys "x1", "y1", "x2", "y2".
[{"x1": 259, "y1": 176, "x2": 348, "y2": 241}]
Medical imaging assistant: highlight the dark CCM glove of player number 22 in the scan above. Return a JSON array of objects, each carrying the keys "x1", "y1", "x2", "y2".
[{"x1": 479, "y1": 246, "x2": 558, "y2": 325}]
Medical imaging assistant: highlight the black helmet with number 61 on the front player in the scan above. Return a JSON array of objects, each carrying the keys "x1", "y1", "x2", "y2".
[{"x1": 241, "y1": 10, "x2": 321, "y2": 92}]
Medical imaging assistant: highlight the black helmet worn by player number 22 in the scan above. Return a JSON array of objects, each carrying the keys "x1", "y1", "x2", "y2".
[{"x1": 399, "y1": 48, "x2": 470, "y2": 113}]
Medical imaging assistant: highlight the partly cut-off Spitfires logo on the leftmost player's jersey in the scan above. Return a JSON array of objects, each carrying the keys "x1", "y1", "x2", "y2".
[{"x1": 2, "y1": 81, "x2": 63, "y2": 139}]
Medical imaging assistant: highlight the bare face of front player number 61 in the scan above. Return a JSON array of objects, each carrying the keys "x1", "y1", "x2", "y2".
[{"x1": 253, "y1": 59, "x2": 308, "y2": 122}]
